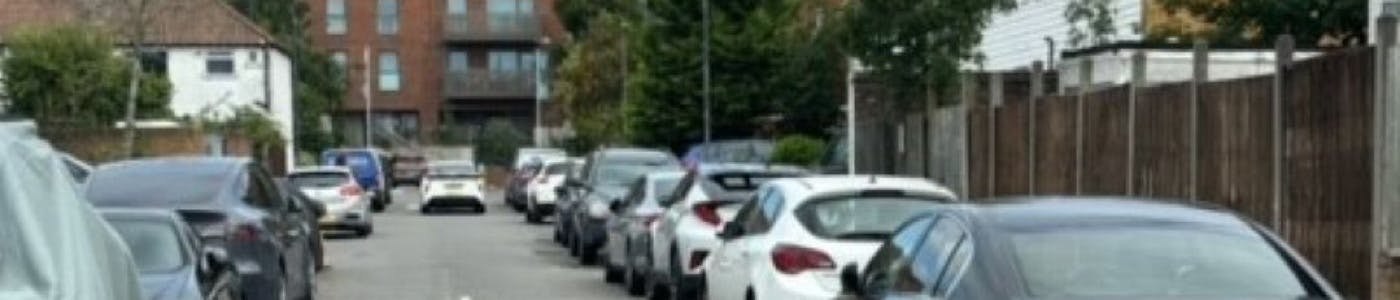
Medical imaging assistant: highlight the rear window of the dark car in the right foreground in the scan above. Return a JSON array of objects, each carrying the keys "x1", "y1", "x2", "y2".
[{"x1": 1009, "y1": 224, "x2": 1308, "y2": 299}]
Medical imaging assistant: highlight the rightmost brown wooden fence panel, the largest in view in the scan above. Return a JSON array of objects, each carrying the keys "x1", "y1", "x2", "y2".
[{"x1": 1280, "y1": 49, "x2": 1373, "y2": 297}]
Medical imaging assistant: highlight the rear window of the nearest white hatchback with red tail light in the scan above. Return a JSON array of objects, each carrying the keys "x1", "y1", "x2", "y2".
[{"x1": 794, "y1": 196, "x2": 946, "y2": 240}]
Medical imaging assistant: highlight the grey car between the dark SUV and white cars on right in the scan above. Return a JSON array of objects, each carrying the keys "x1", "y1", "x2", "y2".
[{"x1": 603, "y1": 171, "x2": 686, "y2": 296}]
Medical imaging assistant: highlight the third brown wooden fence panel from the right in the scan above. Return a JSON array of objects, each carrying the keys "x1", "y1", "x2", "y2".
[{"x1": 1133, "y1": 83, "x2": 1191, "y2": 198}]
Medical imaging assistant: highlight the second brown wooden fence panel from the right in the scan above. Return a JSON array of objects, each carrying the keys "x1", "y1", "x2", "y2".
[{"x1": 1197, "y1": 76, "x2": 1274, "y2": 224}]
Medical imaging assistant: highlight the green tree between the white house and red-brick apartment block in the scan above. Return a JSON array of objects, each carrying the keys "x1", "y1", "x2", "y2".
[{"x1": 227, "y1": 0, "x2": 349, "y2": 153}]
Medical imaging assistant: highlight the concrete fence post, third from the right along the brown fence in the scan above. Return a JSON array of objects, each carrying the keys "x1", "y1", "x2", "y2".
[{"x1": 1186, "y1": 39, "x2": 1211, "y2": 200}]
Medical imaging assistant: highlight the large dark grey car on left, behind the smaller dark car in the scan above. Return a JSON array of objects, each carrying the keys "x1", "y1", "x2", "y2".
[{"x1": 87, "y1": 157, "x2": 316, "y2": 299}]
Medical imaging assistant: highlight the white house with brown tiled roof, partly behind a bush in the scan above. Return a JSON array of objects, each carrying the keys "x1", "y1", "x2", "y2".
[{"x1": 0, "y1": 0, "x2": 295, "y2": 165}]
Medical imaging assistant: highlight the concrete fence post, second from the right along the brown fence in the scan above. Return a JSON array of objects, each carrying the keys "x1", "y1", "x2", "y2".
[{"x1": 1270, "y1": 35, "x2": 1294, "y2": 234}]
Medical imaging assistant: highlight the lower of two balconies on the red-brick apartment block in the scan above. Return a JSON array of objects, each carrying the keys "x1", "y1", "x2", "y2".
[{"x1": 442, "y1": 69, "x2": 535, "y2": 100}]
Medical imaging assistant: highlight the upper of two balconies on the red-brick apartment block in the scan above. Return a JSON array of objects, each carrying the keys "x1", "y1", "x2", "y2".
[{"x1": 442, "y1": 14, "x2": 543, "y2": 45}]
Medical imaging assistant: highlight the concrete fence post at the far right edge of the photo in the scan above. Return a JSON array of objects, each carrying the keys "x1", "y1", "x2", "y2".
[{"x1": 1371, "y1": 14, "x2": 1400, "y2": 299}]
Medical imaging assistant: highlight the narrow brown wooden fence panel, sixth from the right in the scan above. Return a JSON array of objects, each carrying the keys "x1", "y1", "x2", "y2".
[{"x1": 993, "y1": 101, "x2": 1030, "y2": 196}]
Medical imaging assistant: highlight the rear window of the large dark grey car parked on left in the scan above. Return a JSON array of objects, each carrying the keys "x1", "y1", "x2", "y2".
[{"x1": 87, "y1": 164, "x2": 232, "y2": 207}]
